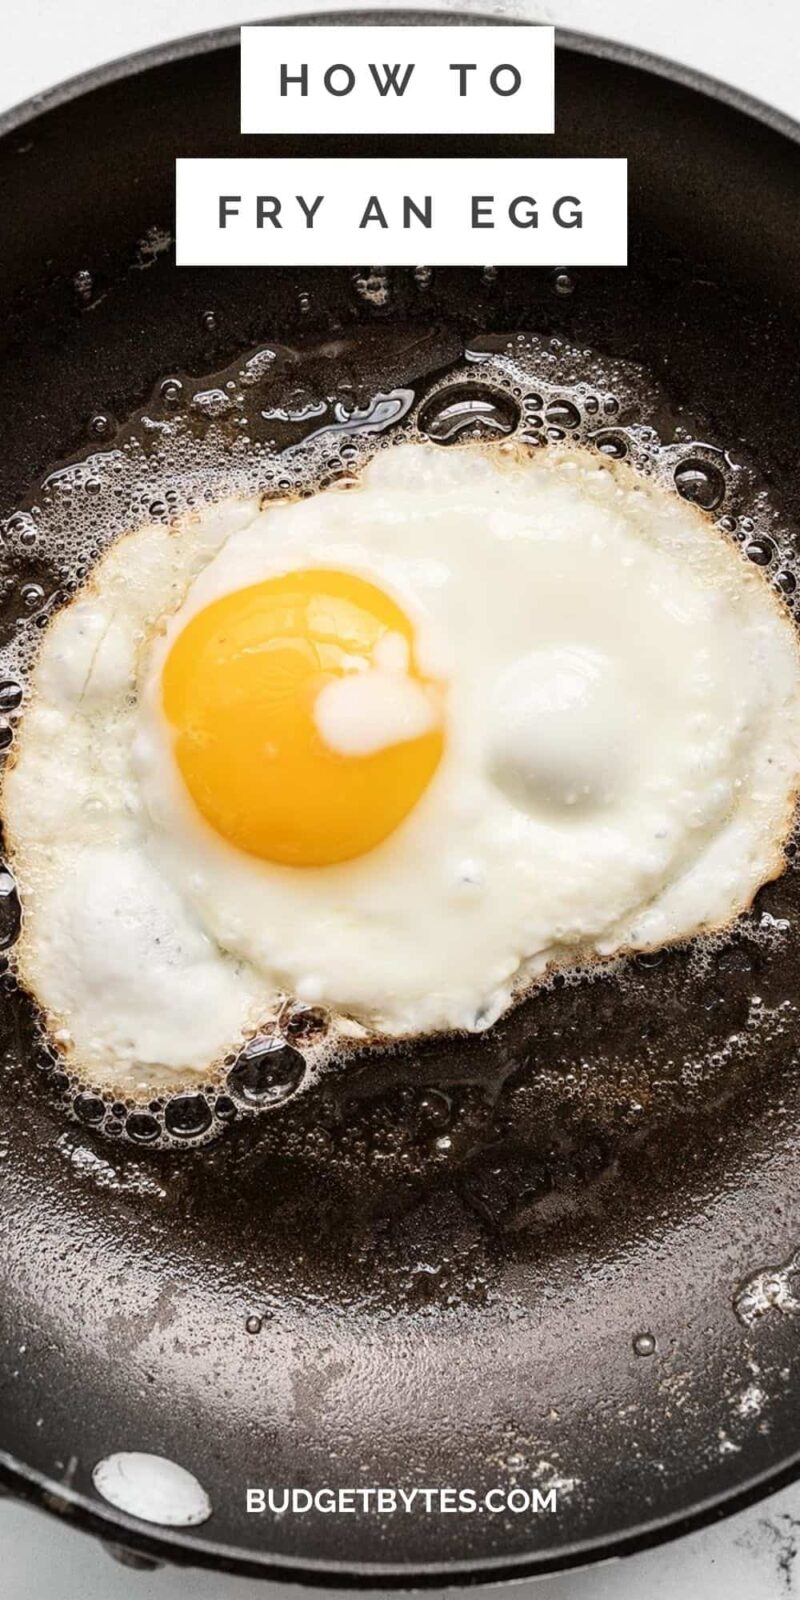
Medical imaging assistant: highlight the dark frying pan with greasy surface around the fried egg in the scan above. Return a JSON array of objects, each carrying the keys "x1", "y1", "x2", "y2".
[{"x1": 0, "y1": 13, "x2": 800, "y2": 1586}]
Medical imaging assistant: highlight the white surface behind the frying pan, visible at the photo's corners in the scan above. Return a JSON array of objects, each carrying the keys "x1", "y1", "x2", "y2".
[{"x1": 0, "y1": 0, "x2": 800, "y2": 1600}]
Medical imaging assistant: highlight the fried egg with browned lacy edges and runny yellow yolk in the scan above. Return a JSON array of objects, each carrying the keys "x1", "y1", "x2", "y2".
[{"x1": 3, "y1": 443, "x2": 800, "y2": 1086}]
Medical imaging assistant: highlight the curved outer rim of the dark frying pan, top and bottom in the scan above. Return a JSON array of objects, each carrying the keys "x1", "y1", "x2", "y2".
[{"x1": 0, "y1": 5, "x2": 800, "y2": 1590}]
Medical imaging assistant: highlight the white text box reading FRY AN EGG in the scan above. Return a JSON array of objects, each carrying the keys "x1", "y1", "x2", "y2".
[{"x1": 176, "y1": 157, "x2": 627, "y2": 267}]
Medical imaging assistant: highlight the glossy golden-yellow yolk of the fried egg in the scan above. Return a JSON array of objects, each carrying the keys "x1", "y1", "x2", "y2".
[{"x1": 162, "y1": 570, "x2": 443, "y2": 867}]
